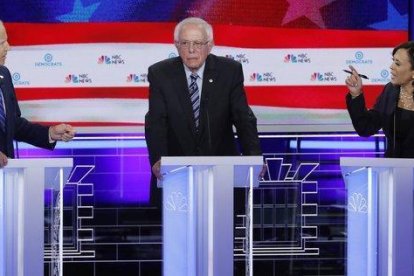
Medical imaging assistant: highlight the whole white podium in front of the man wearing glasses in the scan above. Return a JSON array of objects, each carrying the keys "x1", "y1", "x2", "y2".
[{"x1": 158, "y1": 156, "x2": 263, "y2": 276}]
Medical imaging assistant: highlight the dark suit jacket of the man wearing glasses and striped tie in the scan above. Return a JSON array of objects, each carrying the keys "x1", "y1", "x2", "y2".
[{"x1": 145, "y1": 54, "x2": 261, "y2": 166}]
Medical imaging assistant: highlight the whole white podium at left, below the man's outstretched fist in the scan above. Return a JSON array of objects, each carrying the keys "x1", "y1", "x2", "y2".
[{"x1": 0, "y1": 158, "x2": 73, "y2": 276}]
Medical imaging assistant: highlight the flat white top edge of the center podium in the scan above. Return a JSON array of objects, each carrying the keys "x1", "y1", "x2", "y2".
[{"x1": 161, "y1": 156, "x2": 263, "y2": 167}]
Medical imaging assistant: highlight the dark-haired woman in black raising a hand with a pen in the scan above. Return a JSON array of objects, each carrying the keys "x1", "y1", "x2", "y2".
[{"x1": 345, "y1": 41, "x2": 414, "y2": 158}]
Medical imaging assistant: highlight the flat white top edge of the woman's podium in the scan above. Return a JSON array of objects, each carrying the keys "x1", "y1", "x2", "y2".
[{"x1": 339, "y1": 157, "x2": 414, "y2": 168}]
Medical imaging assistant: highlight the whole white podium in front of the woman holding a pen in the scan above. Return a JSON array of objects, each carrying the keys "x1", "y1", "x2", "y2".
[{"x1": 340, "y1": 158, "x2": 414, "y2": 276}]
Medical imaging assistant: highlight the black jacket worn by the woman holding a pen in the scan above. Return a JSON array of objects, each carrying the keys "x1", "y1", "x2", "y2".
[{"x1": 346, "y1": 83, "x2": 414, "y2": 158}]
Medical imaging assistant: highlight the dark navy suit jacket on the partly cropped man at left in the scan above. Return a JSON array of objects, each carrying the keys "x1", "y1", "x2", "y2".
[{"x1": 0, "y1": 65, "x2": 56, "y2": 158}]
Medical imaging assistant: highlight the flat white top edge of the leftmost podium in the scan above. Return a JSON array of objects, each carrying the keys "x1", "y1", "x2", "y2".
[{"x1": 4, "y1": 158, "x2": 73, "y2": 169}]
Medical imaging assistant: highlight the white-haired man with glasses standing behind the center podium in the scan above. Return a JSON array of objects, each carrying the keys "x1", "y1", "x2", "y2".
[{"x1": 145, "y1": 17, "x2": 261, "y2": 203}]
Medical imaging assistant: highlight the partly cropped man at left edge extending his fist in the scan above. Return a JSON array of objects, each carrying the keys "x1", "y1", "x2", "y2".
[{"x1": 0, "y1": 21, "x2": 75, "y2": 167}]
